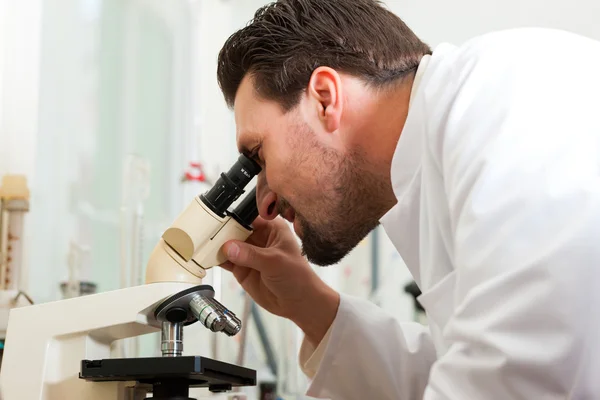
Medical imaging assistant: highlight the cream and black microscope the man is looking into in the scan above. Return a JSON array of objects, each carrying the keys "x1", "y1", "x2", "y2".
[{"x1": 0, "y1": 155, "x2": 260, "y2": 400}]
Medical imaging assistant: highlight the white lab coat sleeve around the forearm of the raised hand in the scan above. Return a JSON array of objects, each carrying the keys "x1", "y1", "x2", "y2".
[{"x1": 300, "y1": 294, "x2": 436, "y2": 400}]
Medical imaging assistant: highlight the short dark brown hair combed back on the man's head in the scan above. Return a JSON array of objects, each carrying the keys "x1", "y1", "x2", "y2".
[{"x1": 217, "y1": 0, "x2": 431, "y2": 111}]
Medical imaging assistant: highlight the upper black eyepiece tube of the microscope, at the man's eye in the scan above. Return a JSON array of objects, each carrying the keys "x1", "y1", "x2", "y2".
[{"x1": 200, "y1": 154, "x2": 261, "y2": 217}]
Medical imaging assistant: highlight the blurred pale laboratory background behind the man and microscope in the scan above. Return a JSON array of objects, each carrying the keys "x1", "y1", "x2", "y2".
[{"x1": 0, "y1": 0, "x2": 600, "y2": 399}]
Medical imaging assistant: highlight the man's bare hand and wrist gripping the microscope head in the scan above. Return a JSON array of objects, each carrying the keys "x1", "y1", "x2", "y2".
[{"x1": 221, "y1": 217, "x2": 340, "y2": 345}]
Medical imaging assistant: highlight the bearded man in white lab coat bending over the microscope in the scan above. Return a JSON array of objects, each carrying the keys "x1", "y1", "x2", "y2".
[{"x1": 218, "y1": 0, "x2": 600, "y2": 400}]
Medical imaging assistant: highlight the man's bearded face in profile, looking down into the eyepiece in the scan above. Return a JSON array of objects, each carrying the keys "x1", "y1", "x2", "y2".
[{"x1": 234, "y1": 72, "x2": 389, "y2": 266}]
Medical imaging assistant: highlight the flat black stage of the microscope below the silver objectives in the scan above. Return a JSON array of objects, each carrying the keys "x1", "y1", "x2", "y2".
[{"x1": 79, "y1": 356, "x2": 256, "y2": 392}]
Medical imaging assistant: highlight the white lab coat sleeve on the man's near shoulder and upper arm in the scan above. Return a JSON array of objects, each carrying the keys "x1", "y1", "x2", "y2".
[{"x1": 424, "y1": 40, "x2": 600, "y2": 400}]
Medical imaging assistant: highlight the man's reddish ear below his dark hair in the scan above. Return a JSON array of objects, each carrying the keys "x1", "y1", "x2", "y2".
[{"x1": 307, "y1": 67, "x2": 343, "y2": 133}]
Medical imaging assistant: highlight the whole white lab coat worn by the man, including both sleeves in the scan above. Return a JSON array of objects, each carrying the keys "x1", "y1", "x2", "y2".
[{"x1": 301, "y1": 29, "x2": 600, "y2": 400}]
